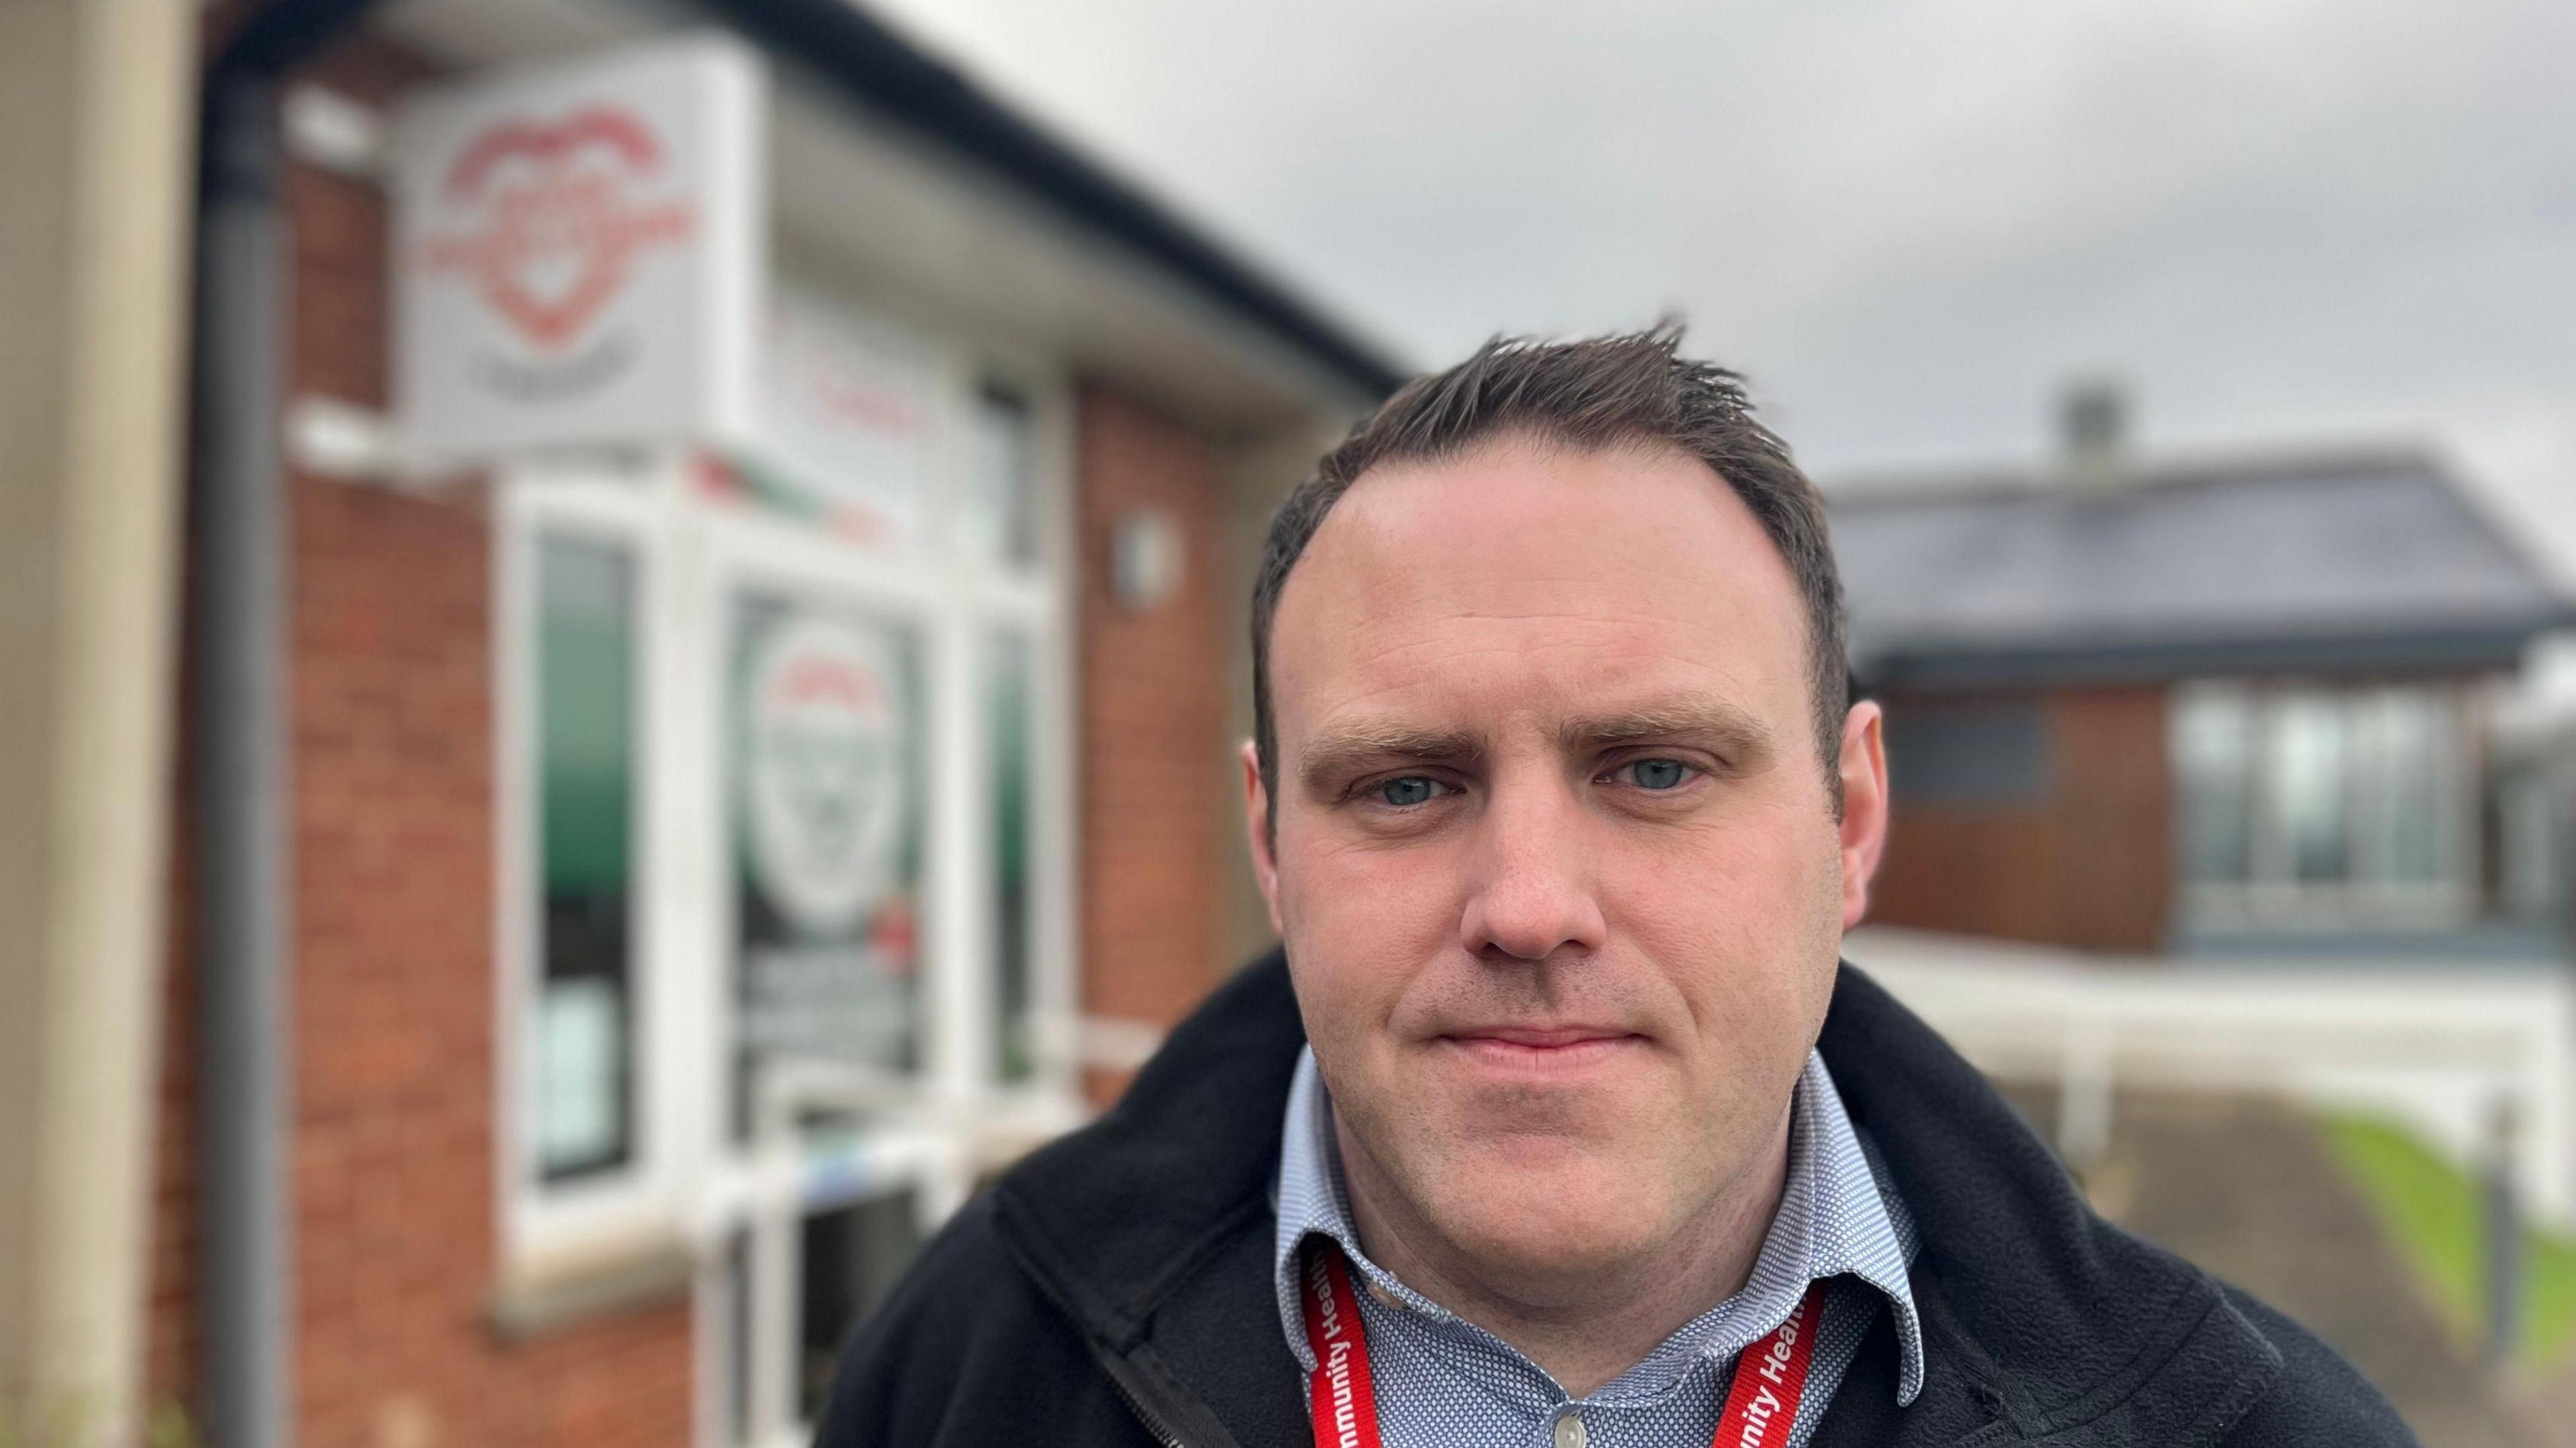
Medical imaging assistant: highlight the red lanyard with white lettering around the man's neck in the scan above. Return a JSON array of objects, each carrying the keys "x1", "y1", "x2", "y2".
[{"x1": 1303, "y1": 1239, "x2": 1824, "y2": 1448}]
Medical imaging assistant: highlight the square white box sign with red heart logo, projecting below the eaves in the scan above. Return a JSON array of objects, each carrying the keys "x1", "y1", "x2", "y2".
[{"x1": 394, "y1": 36, "x2": 767, "y2": 466}]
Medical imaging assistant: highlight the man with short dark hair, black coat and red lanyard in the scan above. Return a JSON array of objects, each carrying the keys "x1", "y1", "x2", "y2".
[{"x1": 822, "y1": 330, "x2": 2411, "y2": 1448}]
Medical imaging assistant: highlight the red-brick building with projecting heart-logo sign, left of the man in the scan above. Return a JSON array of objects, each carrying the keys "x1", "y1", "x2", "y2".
[{"x1": 150, "y1": 0, "x2": 1396, "y2": 1448}]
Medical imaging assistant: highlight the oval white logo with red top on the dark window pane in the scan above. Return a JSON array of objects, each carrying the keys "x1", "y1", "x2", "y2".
[{"x1": 745, "y1": 616, "x2": 904, "y2": 936}]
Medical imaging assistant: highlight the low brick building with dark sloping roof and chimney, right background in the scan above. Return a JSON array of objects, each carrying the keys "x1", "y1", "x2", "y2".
[{"x1": 1831, "y1": 399, "x2": 2571, "y2": 958}]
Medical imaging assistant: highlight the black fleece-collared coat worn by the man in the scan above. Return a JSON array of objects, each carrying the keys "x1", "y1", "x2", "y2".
[{"x1": 816, "y1": 953, "x2": 2414, "y2": 1448}]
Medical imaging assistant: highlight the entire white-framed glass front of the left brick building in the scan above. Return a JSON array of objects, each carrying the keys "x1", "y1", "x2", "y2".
[{"x1": 494, "y1": 335, "x2": 1082, "y2": 1448}]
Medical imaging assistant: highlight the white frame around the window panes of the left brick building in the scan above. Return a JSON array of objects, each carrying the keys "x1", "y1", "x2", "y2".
[{"x1": 492, "y1": 313, "x2": 1085, "y2": 1448}]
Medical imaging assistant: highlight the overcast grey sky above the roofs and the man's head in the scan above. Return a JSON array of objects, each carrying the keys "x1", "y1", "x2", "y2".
[{"x1": 871, "y1": 0, "x2": 2576, "y2": 577}]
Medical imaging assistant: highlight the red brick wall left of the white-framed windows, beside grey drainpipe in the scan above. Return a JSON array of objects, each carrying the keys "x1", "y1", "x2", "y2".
[{"x1": 152, "y1": 46, "x2": 693, "y2": 1448}]
